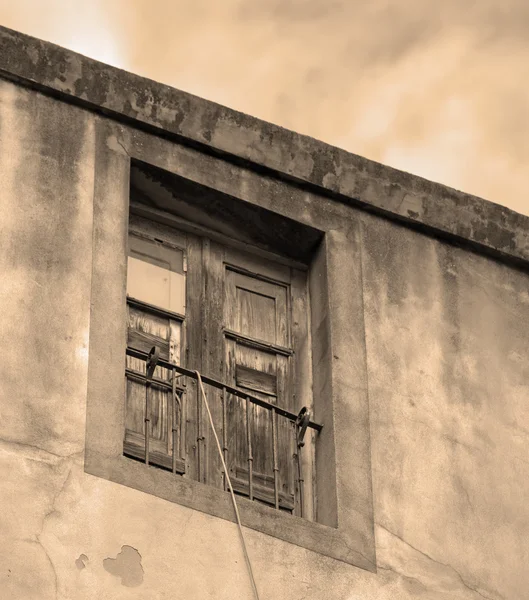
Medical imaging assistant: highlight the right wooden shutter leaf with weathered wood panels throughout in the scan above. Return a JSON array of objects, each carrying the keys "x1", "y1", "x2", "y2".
[{"x1": 224, "y1": 268, "x2": 294, "y2": 510}]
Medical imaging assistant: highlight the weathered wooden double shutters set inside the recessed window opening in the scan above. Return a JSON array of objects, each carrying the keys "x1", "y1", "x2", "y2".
[{"x1": 124, "y1": 217, "x2": 312, "y2": 514}]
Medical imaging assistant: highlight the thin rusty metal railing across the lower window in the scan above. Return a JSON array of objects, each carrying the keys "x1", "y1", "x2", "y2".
[{"x1": 127, "y1": 346, "x2": 323, "y2": 516}]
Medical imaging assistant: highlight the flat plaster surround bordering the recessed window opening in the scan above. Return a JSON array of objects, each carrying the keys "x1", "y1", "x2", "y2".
[{"x1": 85, "y1": 135, "x2": 376, "y2": 571}]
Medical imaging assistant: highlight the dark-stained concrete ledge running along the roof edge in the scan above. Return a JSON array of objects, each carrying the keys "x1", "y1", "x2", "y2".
[{"x1": 0, "y1": 27, "x2": 529, "y2": 263}]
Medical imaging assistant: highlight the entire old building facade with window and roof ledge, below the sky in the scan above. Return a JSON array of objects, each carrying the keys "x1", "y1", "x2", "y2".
[{"x1": 0, "y1": 24, "x2": 529, "y2": 600}]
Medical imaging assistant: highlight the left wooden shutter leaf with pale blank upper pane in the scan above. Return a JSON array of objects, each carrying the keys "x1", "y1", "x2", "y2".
[{"x1": 123, "y1": 235, "x2": 185, "y2": 472}]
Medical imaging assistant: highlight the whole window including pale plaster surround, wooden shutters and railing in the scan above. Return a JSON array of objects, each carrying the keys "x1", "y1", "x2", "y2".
[{"x1": 85, "y1": 152, "x2": 375, "y2": 570}]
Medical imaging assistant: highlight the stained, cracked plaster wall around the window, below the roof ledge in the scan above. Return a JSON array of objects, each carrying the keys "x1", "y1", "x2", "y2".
[{"x1": 0, "y1": 82, "x2": 529, "y2": 600}]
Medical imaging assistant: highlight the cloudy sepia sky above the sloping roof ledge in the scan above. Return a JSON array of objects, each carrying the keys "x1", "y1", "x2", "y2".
[{"x1": 0, "y1": 0, "x2": 529, "y2": 215}]
